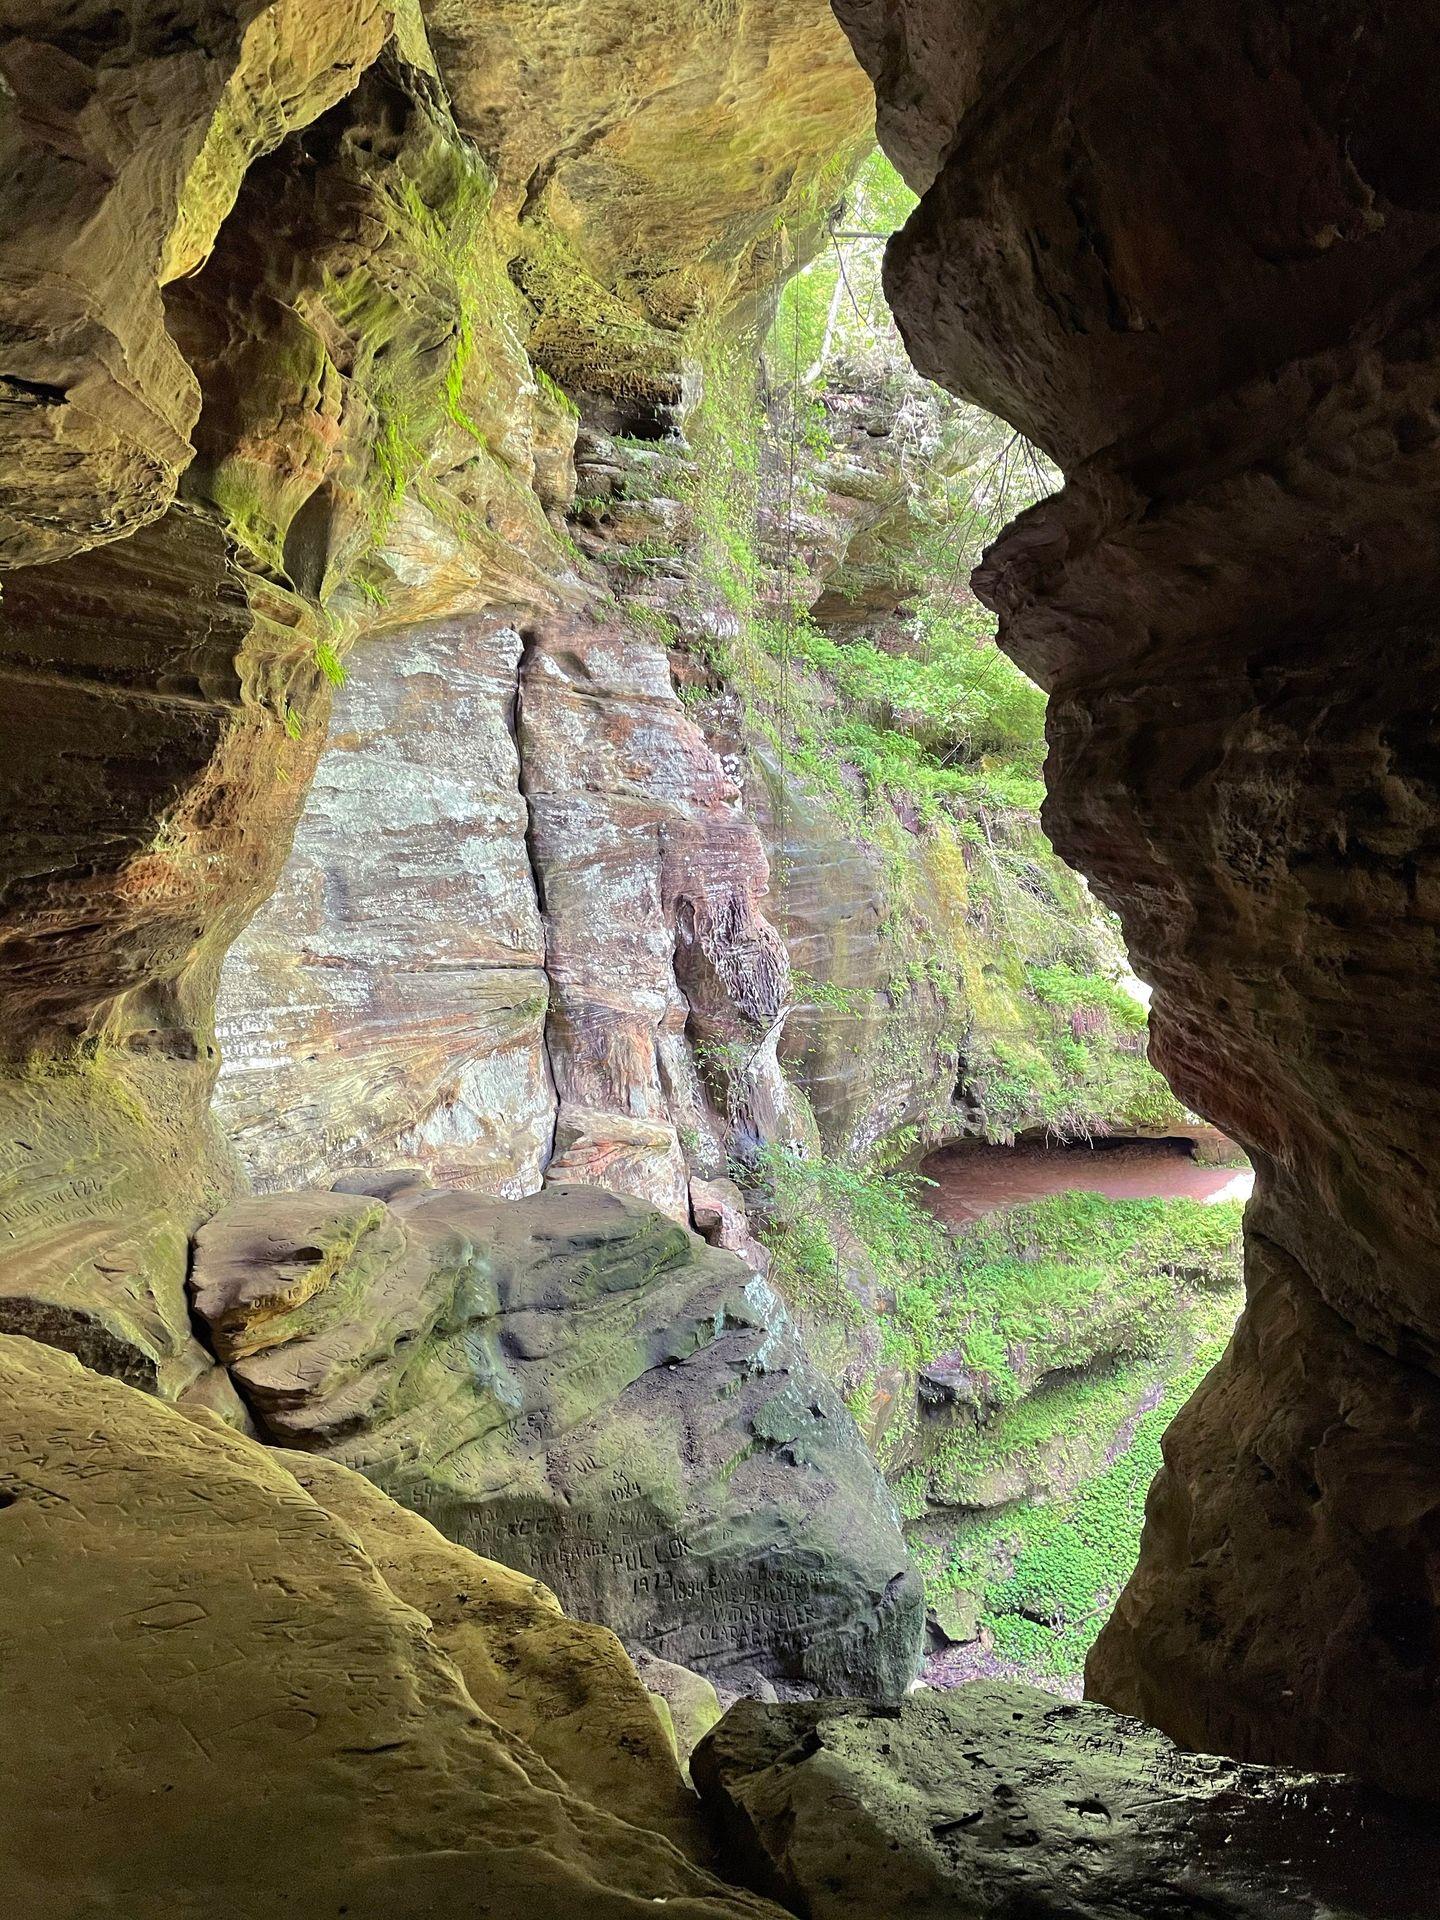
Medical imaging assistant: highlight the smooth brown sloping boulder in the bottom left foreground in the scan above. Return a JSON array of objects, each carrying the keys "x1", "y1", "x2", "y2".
[{"x1": 0, "y1": 1336, "x2": 791, "y2": 1920}]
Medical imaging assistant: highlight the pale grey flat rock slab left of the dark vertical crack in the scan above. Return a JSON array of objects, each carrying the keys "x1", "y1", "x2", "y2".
[{"x1": 217, "y1": 614, "x2": 555, "y2": 1194}]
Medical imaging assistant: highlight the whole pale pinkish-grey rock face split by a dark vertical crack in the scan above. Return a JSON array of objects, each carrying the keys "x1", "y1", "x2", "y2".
[{"x1": 217, "y1": 412, "x2": 804, "y2": 1221}]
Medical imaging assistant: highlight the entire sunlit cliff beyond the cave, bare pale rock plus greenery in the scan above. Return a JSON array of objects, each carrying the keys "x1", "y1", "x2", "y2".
[{"x1": 219, "y1": 149, "x2": 1233, "y2": 1704}]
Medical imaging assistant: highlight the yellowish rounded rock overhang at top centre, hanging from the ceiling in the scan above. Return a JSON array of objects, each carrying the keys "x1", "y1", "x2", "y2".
[{"x1": 424, "y1": 0, "x2": 874, "y2": 408}]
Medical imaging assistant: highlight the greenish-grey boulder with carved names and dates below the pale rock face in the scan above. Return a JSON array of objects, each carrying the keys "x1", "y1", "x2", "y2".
[{"x1": 192, "y1": 1187, "x2": 922, "y2": 1697}]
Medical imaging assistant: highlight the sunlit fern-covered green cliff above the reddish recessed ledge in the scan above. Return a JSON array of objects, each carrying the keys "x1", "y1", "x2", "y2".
[{"x1": 683, "y1": 163, "x2": 1181, "y2": 1139}]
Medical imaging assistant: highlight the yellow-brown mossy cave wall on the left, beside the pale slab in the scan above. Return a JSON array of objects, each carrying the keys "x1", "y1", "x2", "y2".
[{"x1": 0, "y1": 0, "x2": 866, "y2": 1394}]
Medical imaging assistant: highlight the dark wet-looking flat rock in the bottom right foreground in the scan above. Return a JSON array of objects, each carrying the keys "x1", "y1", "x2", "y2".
[{"x1": 691, "y1": 1680, "x2": 1440, "y2": 1920}]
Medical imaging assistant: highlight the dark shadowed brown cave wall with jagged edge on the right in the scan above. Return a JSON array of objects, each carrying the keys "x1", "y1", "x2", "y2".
[{"x1": 837, "y1": 0, "x2": 1440, "y2": 1795}]
